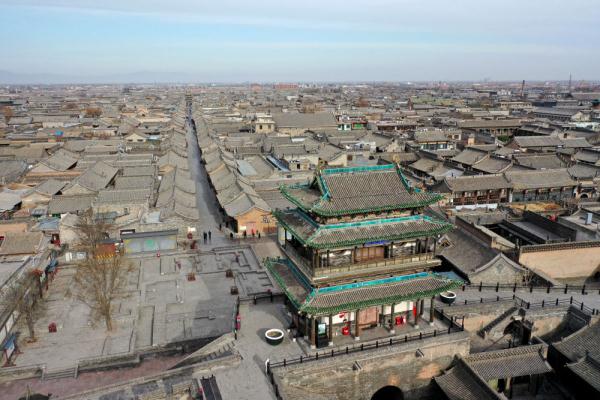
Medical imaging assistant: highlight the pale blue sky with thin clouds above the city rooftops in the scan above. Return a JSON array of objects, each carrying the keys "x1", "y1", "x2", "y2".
[{"x1": 0, "y1": 0, "x2": 600, "y2": 83}]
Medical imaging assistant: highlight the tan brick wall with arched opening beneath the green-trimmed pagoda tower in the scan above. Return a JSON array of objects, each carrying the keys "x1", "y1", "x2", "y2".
[{"x1": 274, "y1": 332, "x2": 470, "y2": 400}]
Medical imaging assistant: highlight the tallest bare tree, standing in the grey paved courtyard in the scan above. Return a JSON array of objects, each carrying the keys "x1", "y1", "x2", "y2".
[{"x1": 74, "y1": 210, "x2": 133, "y2": 331}]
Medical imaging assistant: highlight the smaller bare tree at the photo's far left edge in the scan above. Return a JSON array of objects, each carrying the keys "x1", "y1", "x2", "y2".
[{"x1": 2, "y1": 271, "x2": 44, "y2": 342}]
